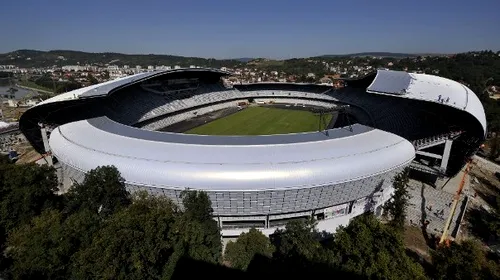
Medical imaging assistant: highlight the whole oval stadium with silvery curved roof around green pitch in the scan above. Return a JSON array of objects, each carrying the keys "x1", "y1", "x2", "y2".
[{"x1": 20, "y1": 68, "x2": 486, "y2": 237}]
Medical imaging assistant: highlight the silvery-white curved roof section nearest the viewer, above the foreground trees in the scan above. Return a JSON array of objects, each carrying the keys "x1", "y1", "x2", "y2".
[{"x1": 50, "y1": 117, "x2": 415, "y2": 191}]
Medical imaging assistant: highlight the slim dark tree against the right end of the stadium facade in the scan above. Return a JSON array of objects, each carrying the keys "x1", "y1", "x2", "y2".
[{"x1": 384, "y1": 169, "x2": 410, "y2": 231}]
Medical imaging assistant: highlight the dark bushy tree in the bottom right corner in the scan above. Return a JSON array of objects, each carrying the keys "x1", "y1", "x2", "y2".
[{"x1": 432, "y1": 238, "x2": 500, "y2": 279}]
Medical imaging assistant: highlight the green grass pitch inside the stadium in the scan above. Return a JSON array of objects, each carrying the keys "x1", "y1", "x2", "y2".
[{"x1": 185, "y1": 107, "x2": 332, "y2": 135}]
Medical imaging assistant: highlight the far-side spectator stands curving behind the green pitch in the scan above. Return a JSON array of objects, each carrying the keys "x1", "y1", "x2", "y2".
[{"x1": 104, "y1": 83, "x2": 450, "y2": 140}]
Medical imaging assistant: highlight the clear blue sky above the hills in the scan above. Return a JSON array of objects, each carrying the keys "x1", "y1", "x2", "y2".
[{"x1": 0, "y1": 0, "x2": 500, "y2": 58}]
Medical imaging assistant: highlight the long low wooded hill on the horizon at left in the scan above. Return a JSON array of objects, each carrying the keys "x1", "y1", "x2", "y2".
[{"x1": 0, "y1": 50, "x2": 243, "y2": 68}]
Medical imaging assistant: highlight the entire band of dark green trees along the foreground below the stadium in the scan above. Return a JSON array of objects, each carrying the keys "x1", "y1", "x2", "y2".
[{"x1": 0, "y1": 160, "x2": 500, "y2": 280}]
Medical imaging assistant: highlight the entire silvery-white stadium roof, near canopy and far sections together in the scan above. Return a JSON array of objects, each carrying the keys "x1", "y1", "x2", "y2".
[{"x1": 22, "y1": 69, "x2": 486, "y2": 194}]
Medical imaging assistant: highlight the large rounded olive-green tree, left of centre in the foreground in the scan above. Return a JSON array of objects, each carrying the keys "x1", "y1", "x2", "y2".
[{"x1": 72, "y1": 193, "x2": 183, "y2": 279}]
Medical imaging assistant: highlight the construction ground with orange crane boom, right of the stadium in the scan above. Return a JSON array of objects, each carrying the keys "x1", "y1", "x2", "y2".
[{"x1": 405, "y1": 156, "x2": 500, "y2": 261}]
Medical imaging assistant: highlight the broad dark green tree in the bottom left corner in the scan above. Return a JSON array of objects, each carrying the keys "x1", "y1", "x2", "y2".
[{"x1": 6, "y1": 209, "x2": 101, "y2": 279}]
